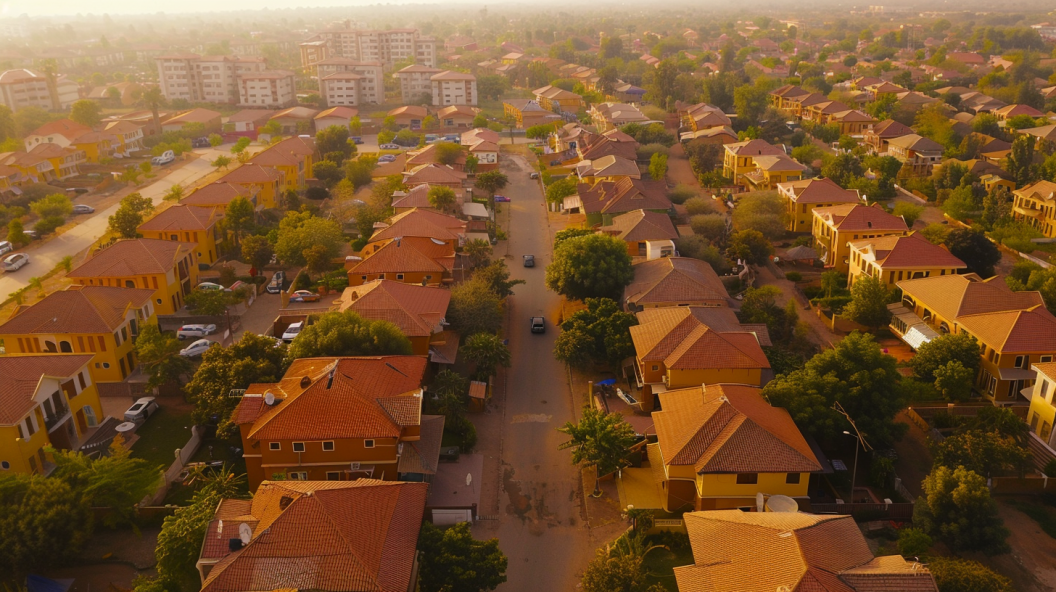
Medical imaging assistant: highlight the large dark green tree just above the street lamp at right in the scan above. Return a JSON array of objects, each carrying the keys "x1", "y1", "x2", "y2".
[{"x1": 762, "y1": 331, "x2": 906, "y2": 445}]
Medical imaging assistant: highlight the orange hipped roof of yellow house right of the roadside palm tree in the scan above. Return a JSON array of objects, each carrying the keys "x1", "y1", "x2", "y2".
[{"x1": 653, "y1": 384, "x2": 822, "y2": 474}]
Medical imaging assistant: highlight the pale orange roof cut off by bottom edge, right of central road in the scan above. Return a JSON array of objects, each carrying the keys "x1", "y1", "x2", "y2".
[{"x1": 675, "y1": 510, "x2": 939, "y2": 592}]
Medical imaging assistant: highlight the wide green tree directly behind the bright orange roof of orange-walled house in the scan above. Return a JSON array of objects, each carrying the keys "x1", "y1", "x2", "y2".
[{"x1": 288, "y1": 310, "x2": 412, "y2": 361}]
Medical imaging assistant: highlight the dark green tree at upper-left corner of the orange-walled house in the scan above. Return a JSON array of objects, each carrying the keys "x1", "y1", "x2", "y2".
[{"x1": 184, "y1": 331, "x2": 286, "y2": 434}]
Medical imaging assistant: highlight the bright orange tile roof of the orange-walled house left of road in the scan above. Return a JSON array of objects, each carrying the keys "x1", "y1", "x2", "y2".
[{"x1": 234, "y1": 356, "x2": 427, "y2": 440}]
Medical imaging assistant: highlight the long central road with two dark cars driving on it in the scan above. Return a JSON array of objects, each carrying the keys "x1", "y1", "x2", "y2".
[{"x1": 489, "y1": 157, "x2": 595, "y2": 592}]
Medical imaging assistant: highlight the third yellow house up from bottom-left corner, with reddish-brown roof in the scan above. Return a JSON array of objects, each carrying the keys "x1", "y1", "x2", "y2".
[{"x1": 67, "y1": 238, "x2": 199, "y2": 314}]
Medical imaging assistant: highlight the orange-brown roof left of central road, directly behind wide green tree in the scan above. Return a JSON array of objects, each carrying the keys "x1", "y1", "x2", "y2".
[{"x1": 338, "y1": 280, "x2": 451, "y2": 337}]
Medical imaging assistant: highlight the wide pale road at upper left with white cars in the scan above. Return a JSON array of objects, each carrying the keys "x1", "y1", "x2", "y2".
[{"x1": 0, "y1": 153, "x2": 213, "y2": 300}]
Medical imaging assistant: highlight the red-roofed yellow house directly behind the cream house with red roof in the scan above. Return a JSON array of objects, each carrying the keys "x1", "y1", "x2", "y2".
[{"x1": 812, "y1": 204, "x2": 909, "y2": 273}]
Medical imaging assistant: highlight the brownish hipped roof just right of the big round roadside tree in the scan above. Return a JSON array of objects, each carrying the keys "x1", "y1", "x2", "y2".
[{"x1": 620, "y1": 256, "x2": 730, "y2": 312}]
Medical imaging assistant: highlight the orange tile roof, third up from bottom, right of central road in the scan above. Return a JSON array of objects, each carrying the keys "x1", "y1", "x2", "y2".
[{"x1": 630, "y1": 306, "x2": 770, "y2": 369}]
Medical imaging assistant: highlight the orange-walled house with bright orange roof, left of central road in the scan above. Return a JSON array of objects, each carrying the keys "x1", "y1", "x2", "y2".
[{"x1": 231, "y1": 356, "x2": 444, "y2": 490}]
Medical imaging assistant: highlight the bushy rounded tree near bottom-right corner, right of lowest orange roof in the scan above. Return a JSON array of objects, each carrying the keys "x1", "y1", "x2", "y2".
[{"x1": 913, "y1": 465, "x2": 1010, "y2": 554}]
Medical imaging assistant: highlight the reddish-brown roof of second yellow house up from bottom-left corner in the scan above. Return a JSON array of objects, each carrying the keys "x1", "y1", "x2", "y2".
[{"x1": 0, "y1": 285, "x2": 154, "y2": 335}]
